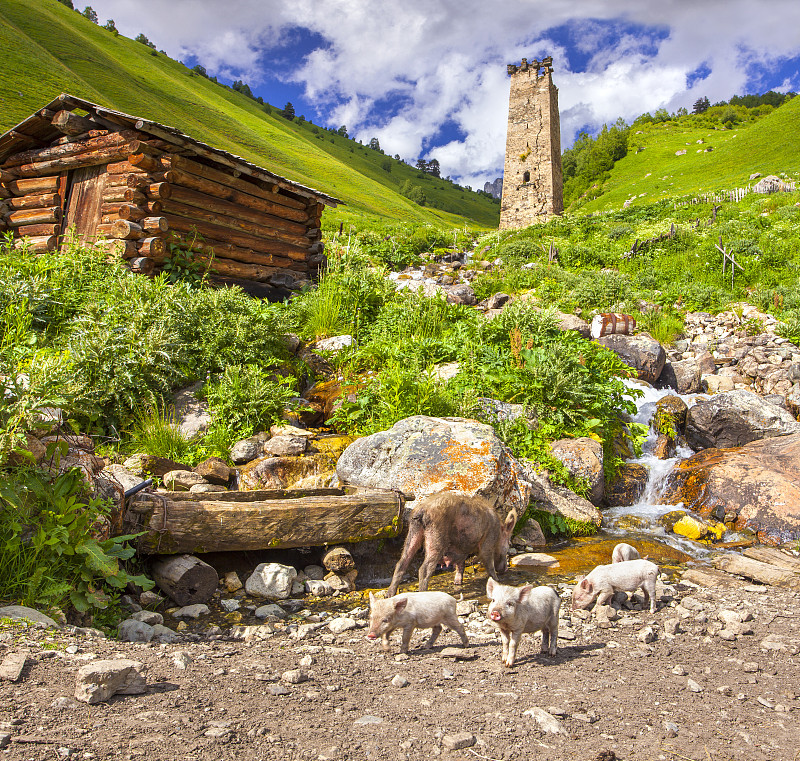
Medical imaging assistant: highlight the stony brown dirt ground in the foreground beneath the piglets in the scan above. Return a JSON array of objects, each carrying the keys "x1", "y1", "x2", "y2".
[{"x1": 0, "y1": 568, "x2": 800, "y2": 761}]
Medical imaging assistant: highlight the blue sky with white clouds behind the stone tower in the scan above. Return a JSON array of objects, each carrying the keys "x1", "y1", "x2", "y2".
[{"x1": 84, "y1": 0, "x2": 800, "y2": 187}]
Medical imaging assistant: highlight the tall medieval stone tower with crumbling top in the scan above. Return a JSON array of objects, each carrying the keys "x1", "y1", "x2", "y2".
[{"x1": 500, "y1": 56, "x2": 564, "y2": 230}]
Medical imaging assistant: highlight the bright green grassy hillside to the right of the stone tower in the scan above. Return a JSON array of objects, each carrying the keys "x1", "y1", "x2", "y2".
[{"x1": 581, "y1": 98, "x2": 800, "y2": 212}]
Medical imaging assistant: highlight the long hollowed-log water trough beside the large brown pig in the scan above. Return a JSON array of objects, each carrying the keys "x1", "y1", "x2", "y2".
[{"x1": 128, "y1": 491, "x2": 402, "y2": 554}]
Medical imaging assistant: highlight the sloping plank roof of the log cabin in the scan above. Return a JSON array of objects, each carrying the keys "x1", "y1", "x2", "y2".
[{"x1": 0, "y1": 93, "x2": 344, "y2": 206}]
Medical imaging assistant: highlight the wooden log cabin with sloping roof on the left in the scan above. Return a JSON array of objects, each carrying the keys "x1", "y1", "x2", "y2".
[{"x1": 0, "y1": 94, "x2": 341, "y2": 292}]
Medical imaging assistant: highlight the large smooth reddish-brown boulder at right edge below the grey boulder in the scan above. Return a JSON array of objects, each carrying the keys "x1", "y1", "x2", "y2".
[{"x1": 662, "y1": 433, "x2": 800, "y2": 544}]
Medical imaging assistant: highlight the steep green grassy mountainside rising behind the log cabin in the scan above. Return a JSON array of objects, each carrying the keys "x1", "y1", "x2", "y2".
[{"x1": 0, "y1": 0, "x2": 499, "y2": 227}]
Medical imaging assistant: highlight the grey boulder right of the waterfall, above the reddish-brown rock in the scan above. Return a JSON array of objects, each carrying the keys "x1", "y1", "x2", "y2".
[{"x1": 686, "y1": 390, "x2": 800, "y2": 450}]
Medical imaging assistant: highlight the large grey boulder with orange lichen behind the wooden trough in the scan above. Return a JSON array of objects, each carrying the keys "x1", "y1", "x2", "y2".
[{"x1": 336, "y1": 415, "x2": 532, "y2": 514}]
